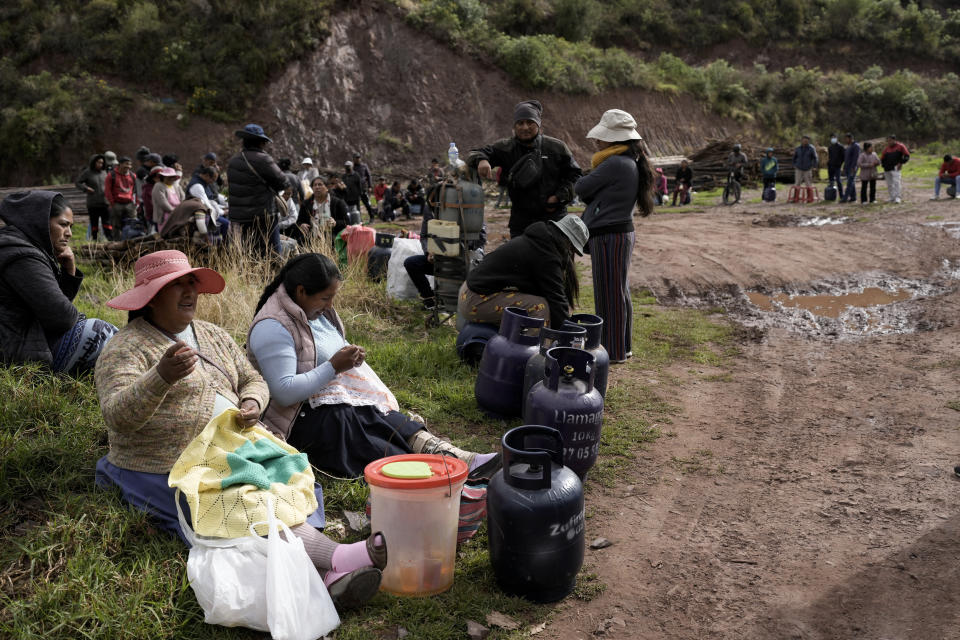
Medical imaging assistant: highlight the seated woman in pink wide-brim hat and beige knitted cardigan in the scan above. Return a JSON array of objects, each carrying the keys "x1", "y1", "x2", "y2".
[{"x1": 95, "y1": 251, "x2": 386, "y2": 607}]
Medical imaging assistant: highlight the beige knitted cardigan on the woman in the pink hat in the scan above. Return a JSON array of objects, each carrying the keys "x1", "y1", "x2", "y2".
[{"x1": 94, "y1": 318, "x2": 270, "y2": 473}]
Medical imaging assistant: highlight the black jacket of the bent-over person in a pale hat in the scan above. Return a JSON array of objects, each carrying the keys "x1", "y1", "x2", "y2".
[{"x1": 467, "y1": 221, "x2": 573, "y2": 327}]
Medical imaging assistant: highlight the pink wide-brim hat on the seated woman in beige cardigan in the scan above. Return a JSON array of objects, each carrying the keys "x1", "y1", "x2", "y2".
[{"x1": 107, "y1": 251, "x2": 227, "y2": 311}]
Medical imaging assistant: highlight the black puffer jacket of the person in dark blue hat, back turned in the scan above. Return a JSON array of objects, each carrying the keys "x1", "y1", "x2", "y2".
[{"x1": 227, "y1": 149, "x2": 287, "y2": 224}]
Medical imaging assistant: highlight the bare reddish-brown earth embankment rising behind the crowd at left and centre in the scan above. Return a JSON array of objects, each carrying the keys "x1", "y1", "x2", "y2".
[{"x1": 94, "y1": 1, "x2": 738, "y2": 182}]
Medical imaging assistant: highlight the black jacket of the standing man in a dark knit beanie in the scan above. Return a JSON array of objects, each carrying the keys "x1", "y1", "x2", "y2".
[{"x1": 467, "y1": 135, "x2": 583, "y2": 237}]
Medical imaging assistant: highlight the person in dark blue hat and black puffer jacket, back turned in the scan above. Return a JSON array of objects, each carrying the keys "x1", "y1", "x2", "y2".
[{"x1": 227, "y1": 124, "x2": 287, "y2": 256}]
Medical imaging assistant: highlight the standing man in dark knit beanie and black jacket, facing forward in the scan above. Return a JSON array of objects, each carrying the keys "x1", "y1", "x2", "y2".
[{"x1": 467, "y1": 100, "x2": 583, "y2": 238}]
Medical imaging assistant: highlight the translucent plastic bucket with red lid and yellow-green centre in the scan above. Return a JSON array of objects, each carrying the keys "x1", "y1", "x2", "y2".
[{"x1": 363, "y1": 453, "x2": 468, "y2": 596}]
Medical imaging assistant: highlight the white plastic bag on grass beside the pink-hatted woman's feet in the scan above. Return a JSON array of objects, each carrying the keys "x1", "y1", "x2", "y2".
[{"x1": 177, "y1": 490, "x2": 340, "y2": 640}]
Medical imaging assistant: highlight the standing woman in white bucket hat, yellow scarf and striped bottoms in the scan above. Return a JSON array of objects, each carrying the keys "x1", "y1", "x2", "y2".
[{"x1": 574, "y1": 109, "x2": 654, "y2": 364}]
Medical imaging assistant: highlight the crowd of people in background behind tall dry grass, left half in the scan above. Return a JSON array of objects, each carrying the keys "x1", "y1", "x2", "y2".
[{"x1": 68, "y1": 131, "x2": 464, "y2": 254}]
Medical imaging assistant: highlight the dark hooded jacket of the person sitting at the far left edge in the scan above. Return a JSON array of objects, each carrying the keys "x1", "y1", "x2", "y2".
[{"x1": 0, "y1": 191, "x2": 83, "y2": 365}]
